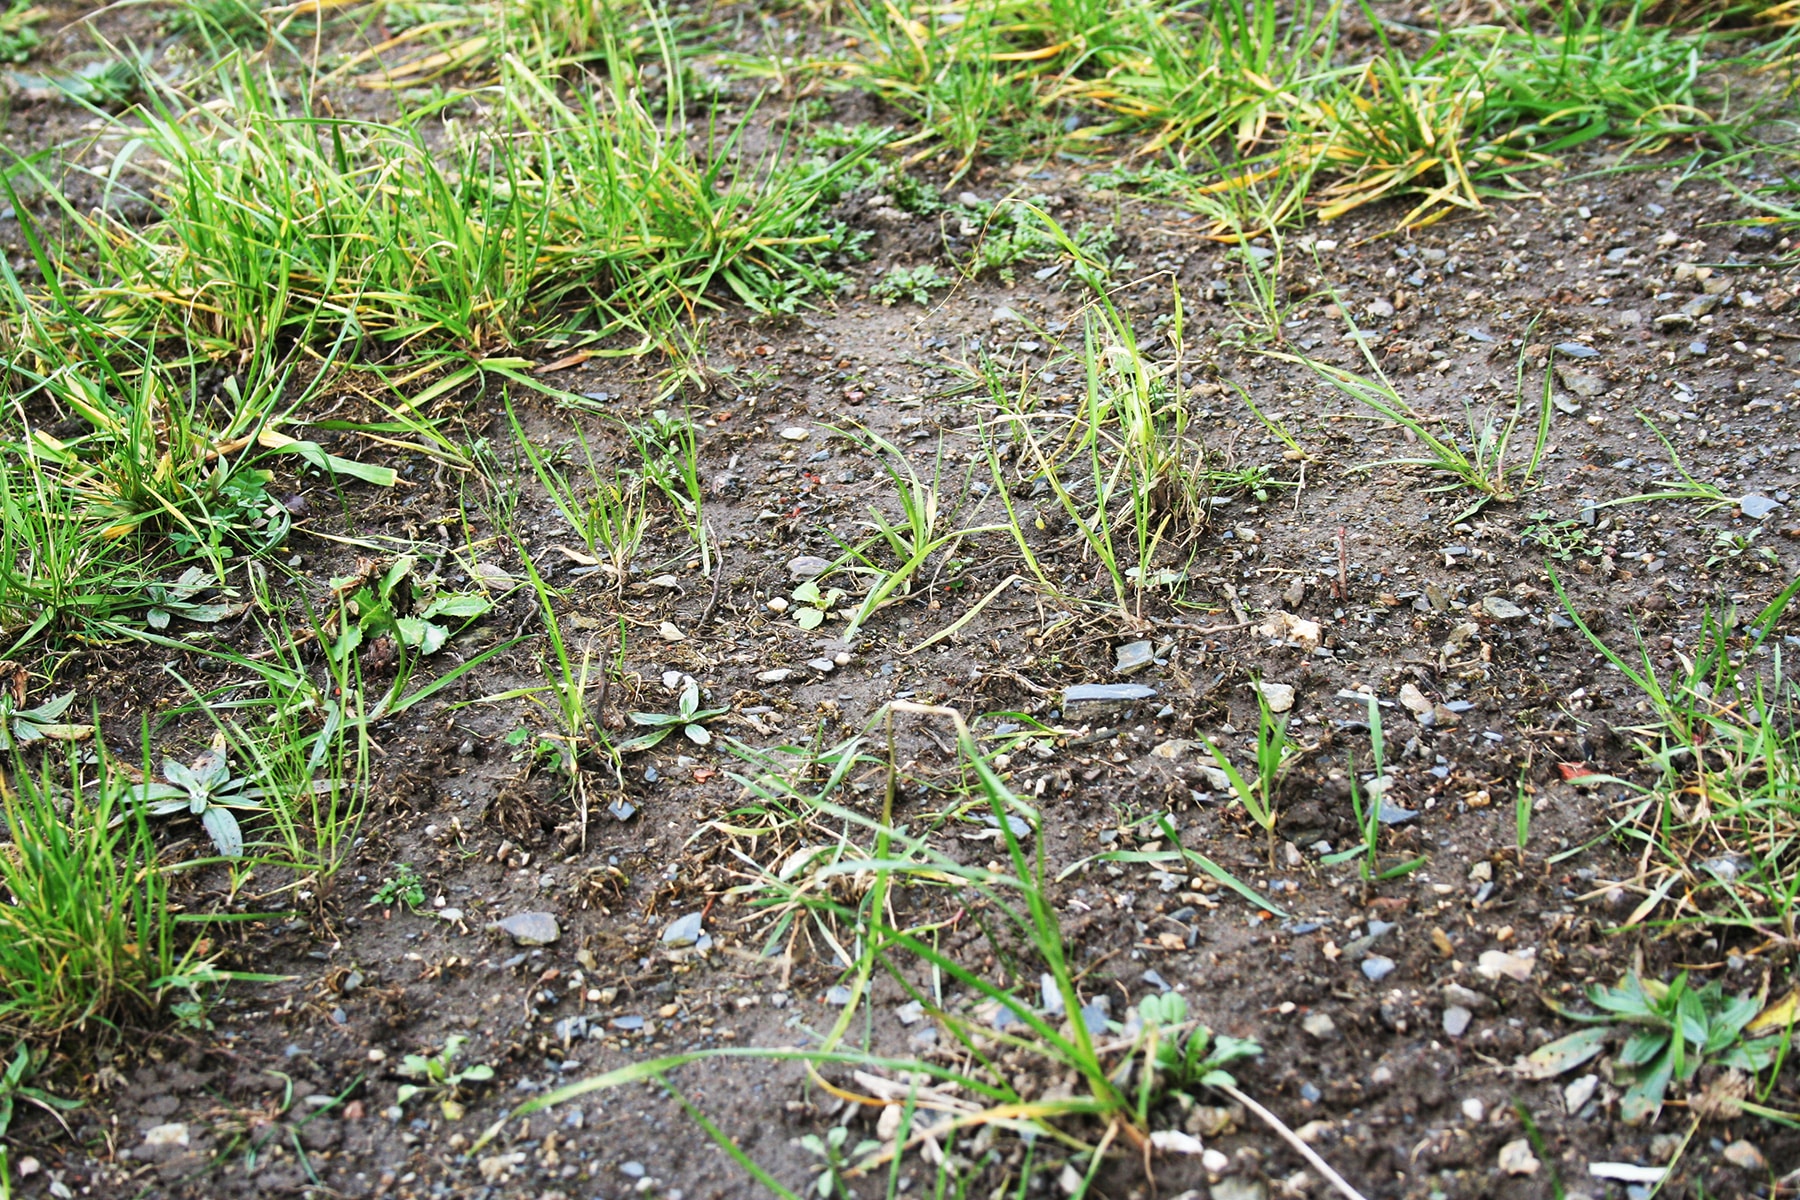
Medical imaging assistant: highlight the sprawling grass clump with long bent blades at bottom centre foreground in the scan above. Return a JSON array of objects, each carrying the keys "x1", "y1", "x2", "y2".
[{"x1": 475, "y1": 702, "x2": 1355, "y2": 1196}]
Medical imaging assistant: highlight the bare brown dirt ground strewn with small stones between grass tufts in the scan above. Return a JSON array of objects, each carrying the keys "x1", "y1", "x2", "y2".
[{"x1": 7, "y1": 2, "x2": 1800, "y2": 1200}]
